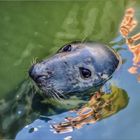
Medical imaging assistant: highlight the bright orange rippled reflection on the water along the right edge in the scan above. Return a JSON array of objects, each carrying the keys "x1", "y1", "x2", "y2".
[{"x1": 120, "y1": 8, "x2": 140, "y2": 82}]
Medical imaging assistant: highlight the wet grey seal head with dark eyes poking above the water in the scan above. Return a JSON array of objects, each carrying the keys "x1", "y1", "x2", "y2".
[{"x1": 29, "y1": 42, "x2": 120, "y2": 95}]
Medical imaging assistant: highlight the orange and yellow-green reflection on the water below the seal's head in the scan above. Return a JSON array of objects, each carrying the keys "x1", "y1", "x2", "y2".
[{"x1": 51, "y1": 86, "x2": 128, "y2": 134}]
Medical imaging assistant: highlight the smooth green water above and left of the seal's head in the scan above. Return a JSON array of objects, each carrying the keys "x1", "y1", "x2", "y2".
[{"x1": 0, "y1": 0, "x2": 127, "y2": 98}]
